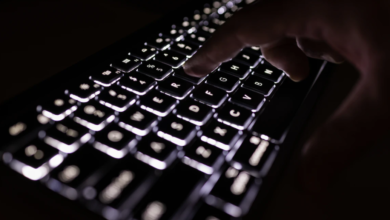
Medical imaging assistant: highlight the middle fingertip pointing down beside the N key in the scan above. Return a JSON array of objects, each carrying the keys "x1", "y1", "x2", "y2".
[{"x1": 261, "y1": 38, "x2": 309, "y2": 81}]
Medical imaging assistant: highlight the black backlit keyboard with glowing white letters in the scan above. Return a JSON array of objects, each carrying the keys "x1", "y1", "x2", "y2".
[{"x1": 0, "y1": 0, "x2": 325, "y2": 220}]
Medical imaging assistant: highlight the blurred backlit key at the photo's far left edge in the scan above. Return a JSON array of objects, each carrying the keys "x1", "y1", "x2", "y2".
[{"x1": 0, "y1": 111, "x2": 50, "y2": 147}]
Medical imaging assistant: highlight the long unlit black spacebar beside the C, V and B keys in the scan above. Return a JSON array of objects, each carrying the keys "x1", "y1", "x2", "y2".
[{"x1": 251, "y1": 77, "x2": 314, "y2": 140}]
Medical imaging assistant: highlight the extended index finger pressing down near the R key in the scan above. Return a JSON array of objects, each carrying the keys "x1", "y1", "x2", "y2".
[{"x1": 184, "y1": 0, "x2": 310, "y2": 76}]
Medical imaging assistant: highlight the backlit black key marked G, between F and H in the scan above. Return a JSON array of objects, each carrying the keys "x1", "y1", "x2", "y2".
[{"x1": 206, "y1": 71, "x2": 240, "y2": 93}]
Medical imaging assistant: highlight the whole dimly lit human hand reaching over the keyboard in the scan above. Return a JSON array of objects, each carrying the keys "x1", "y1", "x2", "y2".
[{"x1": 184, "y1": 0, "x2": 390, "y2": 191}]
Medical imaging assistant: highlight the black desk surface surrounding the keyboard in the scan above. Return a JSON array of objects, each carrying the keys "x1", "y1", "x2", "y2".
[{"x1": 0, "y1": 0, "x2": 390, "y2": 220}]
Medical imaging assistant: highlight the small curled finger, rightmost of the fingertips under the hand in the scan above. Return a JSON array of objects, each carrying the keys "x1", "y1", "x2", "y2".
[{"x1": 297, "y1": 38, "x2": 344, "y2": 63}]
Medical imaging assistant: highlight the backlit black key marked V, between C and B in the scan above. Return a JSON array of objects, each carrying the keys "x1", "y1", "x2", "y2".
[{"x1": 230, "y1": 88, "x2": 265, "y2": 112}]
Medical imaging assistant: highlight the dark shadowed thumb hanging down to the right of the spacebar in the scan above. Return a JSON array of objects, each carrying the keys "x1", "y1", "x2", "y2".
[{"x1": 300, "y1": 80, "x2": 390, "y2": 193}]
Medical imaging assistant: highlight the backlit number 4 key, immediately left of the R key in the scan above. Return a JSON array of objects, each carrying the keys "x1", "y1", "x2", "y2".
[{"x1": 119, "y1": 72, "x2": 156, "y2": 95}]
